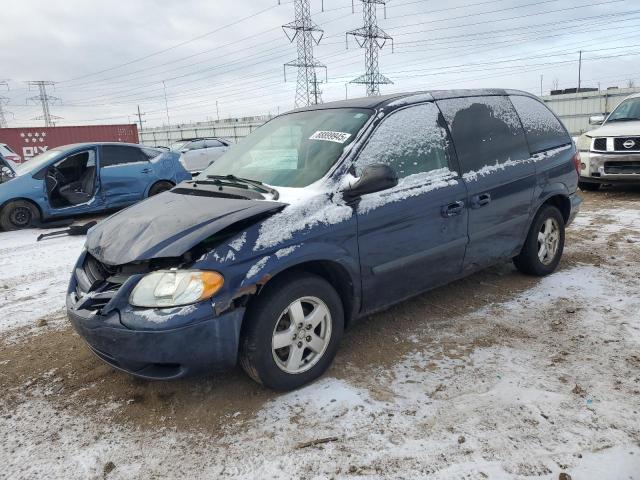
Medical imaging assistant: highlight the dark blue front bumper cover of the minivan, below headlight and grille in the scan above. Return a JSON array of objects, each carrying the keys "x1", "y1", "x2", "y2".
[{"x1": 67, "y1": 297, "x2": 244, "y2": 380}]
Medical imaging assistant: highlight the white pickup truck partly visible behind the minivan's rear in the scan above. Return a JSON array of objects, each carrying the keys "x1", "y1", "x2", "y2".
[{"x1": 576, "y1": 94, "x2": 640, "y2": 190}]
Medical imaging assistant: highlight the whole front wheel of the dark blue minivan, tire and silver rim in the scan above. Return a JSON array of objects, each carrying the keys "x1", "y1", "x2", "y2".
[{"x1": 240, "y1": 272, "x2": 344, "y2": 390}]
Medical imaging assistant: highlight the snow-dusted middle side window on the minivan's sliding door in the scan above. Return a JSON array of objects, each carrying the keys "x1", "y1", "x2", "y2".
[{"x1": 438, "y1": 96, "x2": 529, "y2": 173}]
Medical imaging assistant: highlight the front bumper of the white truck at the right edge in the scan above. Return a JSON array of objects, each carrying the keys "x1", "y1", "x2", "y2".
[{"x1": 580, "y1": 151, "x2": 640, "y2": 183}]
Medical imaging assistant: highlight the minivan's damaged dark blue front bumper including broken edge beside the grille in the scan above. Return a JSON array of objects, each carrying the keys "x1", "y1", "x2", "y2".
[{"x1": 67, "y1": 262, "x2": 245, "y2": 380}]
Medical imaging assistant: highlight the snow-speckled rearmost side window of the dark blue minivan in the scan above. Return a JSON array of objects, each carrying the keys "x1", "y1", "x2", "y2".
[{"x1": 511, "y1": 95, "x2": 571, "y2": 153}]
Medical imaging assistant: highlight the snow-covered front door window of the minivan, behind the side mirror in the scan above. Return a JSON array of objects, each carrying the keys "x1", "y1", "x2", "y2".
[{"x1": 356, "y1": 103, "x2": 450, "y2": 178}]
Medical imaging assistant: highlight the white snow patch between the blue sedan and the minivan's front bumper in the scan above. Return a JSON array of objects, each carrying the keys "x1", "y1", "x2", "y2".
[{"x1": 0, "y1": 230, "x2": 85, "y2": 333}]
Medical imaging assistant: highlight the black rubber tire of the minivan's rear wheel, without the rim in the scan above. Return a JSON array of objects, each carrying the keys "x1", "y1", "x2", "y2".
[{"x1": 513, "y1": 205, "x2": 565, "y2": 277}]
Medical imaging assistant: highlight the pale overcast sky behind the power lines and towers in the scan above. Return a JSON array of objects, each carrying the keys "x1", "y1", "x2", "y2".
[{"x1": 0, "y1": 0, "x2": 640, "y2": 126}]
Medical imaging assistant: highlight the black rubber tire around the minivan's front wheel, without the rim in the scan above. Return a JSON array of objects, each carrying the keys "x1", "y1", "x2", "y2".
[{"x1": 240, "y1": 272, "x2": 344, "y2": 391}]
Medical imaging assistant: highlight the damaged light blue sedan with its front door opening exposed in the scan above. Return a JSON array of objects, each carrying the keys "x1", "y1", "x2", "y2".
[{"x1": 0, "y1": 143, "x2": 191, "y2": 230}]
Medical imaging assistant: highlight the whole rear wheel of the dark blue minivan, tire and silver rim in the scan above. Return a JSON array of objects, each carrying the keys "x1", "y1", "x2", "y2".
[{"x1": 513, "y1": 205, "x2": 565, "y2": 277}]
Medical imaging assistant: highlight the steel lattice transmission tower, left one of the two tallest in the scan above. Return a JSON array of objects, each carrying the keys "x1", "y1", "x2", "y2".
[{"x1": 278, "y1": 0, "x2": 327, "y2": 107}]
